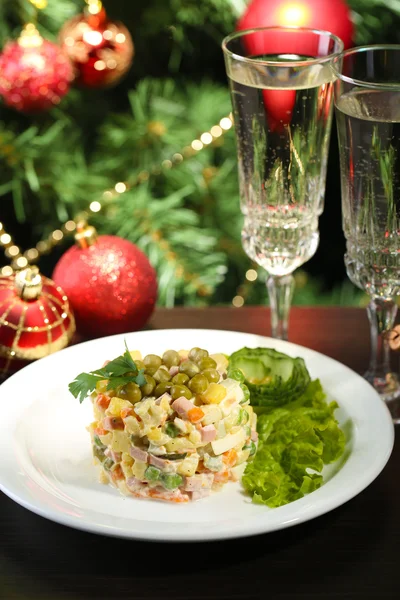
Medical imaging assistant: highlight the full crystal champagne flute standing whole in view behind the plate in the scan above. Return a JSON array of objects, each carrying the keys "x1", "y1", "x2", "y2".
[{"x1": 222, "y1": 27, "x2": 343, "y2": 339}]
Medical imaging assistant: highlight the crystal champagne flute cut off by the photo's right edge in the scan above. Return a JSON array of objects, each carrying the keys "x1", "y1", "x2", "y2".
[{"x1": 334, "y1": 45, "x2": 400, "y2": 423}]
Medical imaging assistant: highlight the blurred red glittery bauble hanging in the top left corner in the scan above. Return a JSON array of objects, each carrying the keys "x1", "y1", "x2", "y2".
[{"x1": 0, "y1": 24, "x2": 74, "y2": 113}]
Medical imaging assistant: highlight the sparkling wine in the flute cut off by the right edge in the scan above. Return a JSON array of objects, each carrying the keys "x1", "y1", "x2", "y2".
[{"x1": 336, "y1": 90, "x2": 400, "y2": 299}]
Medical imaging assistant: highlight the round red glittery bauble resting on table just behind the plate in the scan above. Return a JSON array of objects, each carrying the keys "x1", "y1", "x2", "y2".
[{"x1": 53, "y1": 224, "x2": 157, "y2": 337}]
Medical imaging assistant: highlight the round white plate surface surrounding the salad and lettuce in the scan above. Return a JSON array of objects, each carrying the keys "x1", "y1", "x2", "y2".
[{"x1": 0, "y1": 330, "x2": 394, "y2": 541}]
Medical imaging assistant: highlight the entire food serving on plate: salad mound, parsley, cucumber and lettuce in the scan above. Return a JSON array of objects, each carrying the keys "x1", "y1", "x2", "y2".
[{"x1": 69, "y1": 347, "x2": 345, "y2": 508}]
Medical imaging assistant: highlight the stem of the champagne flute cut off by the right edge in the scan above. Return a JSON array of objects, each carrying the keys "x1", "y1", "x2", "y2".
[{"x1": 366, "y1": 298, "x2": 397, "y2": 389}]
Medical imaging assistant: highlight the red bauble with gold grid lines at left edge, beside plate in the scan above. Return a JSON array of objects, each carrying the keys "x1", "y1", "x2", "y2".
[{"x1": 0, "y1": 267, "x2": 75, "y2": 376}]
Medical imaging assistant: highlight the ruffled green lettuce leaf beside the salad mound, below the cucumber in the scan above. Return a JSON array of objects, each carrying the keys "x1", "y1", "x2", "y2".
[{"x1": 242, "y1": 379, "x2": 345, "y2": 508}]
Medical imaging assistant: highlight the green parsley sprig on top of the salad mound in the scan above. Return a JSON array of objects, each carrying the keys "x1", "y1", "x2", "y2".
[{"x1": 68, "y1": 341, "x2": 146, "y2": 403}]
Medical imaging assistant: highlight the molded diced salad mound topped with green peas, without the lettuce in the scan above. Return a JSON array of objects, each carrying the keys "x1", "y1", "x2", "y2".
[{"x1": 69, "y1": 348, "x2": 258, "y2": 502}]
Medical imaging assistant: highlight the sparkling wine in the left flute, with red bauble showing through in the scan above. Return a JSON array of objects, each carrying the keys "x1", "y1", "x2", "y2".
[{"x1": 228, "y1": 55, "x2": 333, "y2": 276}]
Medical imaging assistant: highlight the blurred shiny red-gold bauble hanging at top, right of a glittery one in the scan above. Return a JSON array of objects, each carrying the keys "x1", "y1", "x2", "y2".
[{"x1": 59, "y1": 0, "x2": 134, "y2": 88}]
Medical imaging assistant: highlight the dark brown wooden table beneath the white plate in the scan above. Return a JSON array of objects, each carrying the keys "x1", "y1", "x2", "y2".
[{"x1": 0, "y1": 307, "x2": 400, "y2": 600}]
